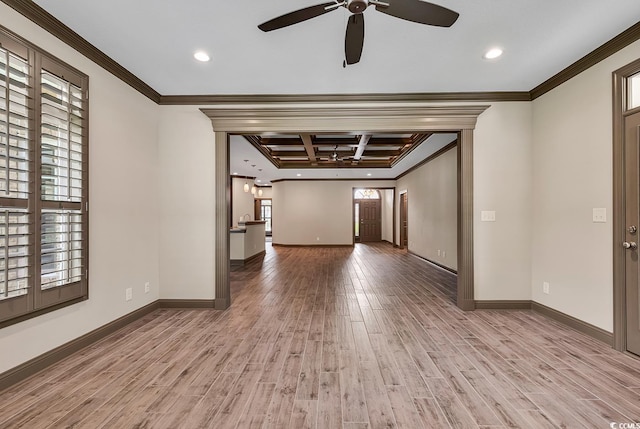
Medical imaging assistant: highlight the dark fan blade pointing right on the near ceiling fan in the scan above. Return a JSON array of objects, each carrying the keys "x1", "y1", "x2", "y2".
[{"x1": 376, "y1": 0, "x2": 460, "y2": 27}]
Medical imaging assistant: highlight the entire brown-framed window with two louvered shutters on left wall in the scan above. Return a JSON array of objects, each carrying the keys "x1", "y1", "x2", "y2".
[{"x1": 0, "y1": 28, "x2": 88, "y2": 326}]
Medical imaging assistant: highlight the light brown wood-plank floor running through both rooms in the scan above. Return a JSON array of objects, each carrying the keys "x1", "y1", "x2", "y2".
[{"x1": 0, "y1": 244, "x2": 640, "y2": 429}]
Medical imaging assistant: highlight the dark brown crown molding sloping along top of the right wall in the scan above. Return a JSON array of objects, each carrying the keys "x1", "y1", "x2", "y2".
[{"x1": 530, "y1": 22, "x2": 640, "y2": 100}]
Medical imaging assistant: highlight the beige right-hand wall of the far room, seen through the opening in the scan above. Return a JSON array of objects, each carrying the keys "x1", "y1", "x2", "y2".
[{"x1": 397, "y1": 145, "x2": 458, "y2": 270}]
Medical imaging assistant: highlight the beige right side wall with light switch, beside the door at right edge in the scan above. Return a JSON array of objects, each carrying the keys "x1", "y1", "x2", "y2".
[{"x1": 531, "y1": 42, "x2": 640, "y2": 331}]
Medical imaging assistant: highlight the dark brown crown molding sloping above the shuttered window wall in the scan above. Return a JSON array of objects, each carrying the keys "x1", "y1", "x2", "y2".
[{"x1": 1, "y1": 0, "x2": 161, "y2": 103}]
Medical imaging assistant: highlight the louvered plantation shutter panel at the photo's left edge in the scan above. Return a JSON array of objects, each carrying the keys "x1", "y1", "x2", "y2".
[{"x1": 0, "y1": 38, "x2": 33, "y2": 320}]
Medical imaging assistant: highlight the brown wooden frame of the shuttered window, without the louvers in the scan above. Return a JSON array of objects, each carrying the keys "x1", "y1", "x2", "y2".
[{"x1": 0, "y1": 26, "x2": 89, "y2": 328}]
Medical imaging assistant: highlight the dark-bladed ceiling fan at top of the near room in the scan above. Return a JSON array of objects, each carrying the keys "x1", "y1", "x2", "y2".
[{"x1": 258, "y1": 0, "x2": 460, "y2": 67}]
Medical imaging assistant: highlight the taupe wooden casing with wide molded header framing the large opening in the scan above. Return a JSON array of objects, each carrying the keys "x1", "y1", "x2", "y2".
[{"x1": 201, "y1": 103, "x2": 489, "y2": 310}]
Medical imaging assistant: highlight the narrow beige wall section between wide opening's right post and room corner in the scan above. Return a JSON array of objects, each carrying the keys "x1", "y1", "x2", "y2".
[{"x1": 473, "y1": 102, "x2": 532, "y2": 301}]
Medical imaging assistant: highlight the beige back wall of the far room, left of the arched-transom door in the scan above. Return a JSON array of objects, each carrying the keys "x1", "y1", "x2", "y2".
[{"x1": 273, "y1": 180, "x2": 394, "y2": 245}]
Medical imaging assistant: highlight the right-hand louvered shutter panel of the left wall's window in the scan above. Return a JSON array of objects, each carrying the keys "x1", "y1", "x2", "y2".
[{"x1": 37, "y1": 58, "x2": 87, "y2": 306}]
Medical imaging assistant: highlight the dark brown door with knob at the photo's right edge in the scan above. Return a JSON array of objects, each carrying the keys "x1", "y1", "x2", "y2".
[{"x1": 622, "y1": 112, "x2": 640, "y2": 355}]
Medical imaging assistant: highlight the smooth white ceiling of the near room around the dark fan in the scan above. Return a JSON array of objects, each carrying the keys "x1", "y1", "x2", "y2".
[{"x1": 35, "y1": 0, "x2": 640, "y2": 95}]
